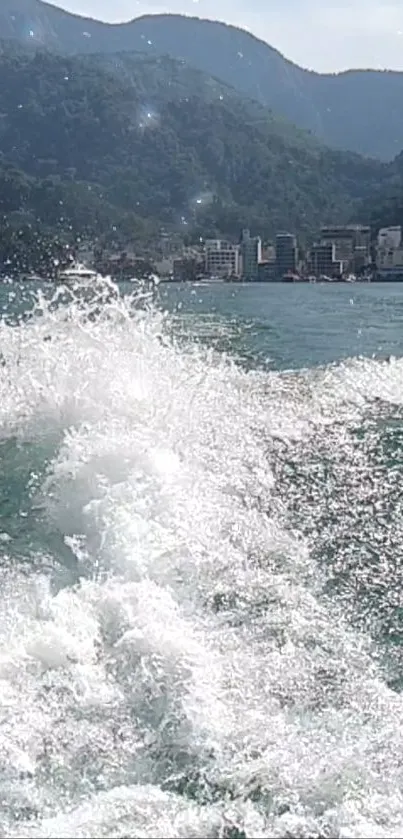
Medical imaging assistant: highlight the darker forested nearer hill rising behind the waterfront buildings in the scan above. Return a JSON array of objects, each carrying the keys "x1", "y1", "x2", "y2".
[{"x1": 0, "y1": 41, "x2": 388, "y2": 251}]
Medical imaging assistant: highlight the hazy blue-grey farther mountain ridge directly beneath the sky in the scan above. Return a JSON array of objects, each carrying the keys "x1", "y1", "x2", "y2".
[{"x1": 0, "y1": 0, "x2": 403, "y2": 161}]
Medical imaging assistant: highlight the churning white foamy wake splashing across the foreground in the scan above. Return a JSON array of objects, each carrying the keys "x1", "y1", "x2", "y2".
[{"x1": 0, "y1": 281, "x2": 403, "y2": 839}]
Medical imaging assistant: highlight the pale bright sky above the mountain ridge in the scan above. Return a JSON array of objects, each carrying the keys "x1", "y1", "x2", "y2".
[{"x1": 48, "y1": 0, "x2": 403, "y2": 72}]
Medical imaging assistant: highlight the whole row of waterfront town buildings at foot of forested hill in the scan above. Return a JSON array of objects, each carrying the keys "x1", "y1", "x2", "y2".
[{"x1": 88, "y1": 224, "x2": 403, "y2": 282}]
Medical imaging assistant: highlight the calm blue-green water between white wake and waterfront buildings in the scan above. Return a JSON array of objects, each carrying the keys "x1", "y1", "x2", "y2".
[{"x1": 159, "y1": 283, "x2": 403, "y2": 370}]
